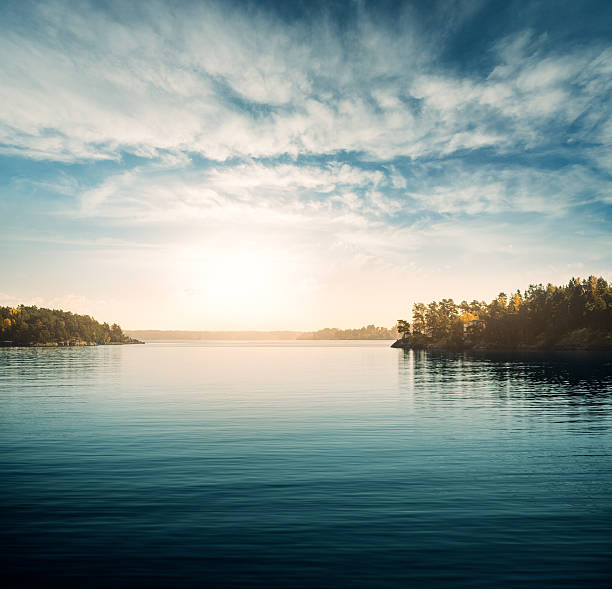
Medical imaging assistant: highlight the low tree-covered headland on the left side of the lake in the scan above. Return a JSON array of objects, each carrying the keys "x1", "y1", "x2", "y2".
[{"x1": 0, "y1": 305, "x2": 138, "y2": 346}]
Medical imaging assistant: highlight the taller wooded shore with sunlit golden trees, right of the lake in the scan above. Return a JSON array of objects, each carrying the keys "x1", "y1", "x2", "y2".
[{"x1": 397, "y1": 276, "x2": 612, "y2": 349}]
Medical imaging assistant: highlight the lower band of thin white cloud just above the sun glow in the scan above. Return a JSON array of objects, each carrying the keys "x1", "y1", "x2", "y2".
[{"x1": 65, "y1": 149, "x2": 609, "y2": 234}]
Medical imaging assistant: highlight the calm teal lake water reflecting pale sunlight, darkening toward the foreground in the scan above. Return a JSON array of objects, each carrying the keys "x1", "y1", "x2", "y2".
[{"x1": 0, "y1": 342, "x2": 612, "y2": 588}]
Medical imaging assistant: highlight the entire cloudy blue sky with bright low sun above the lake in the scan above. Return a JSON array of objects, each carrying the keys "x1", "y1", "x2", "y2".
[{"x1": 0, "y1": 0, "x2": 612, "y2": 330}]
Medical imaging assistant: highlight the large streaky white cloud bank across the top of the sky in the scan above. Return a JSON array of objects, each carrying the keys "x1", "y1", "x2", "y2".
[{"x1": 0, "y1": 3, "x2": 612, "y2": 161}]
